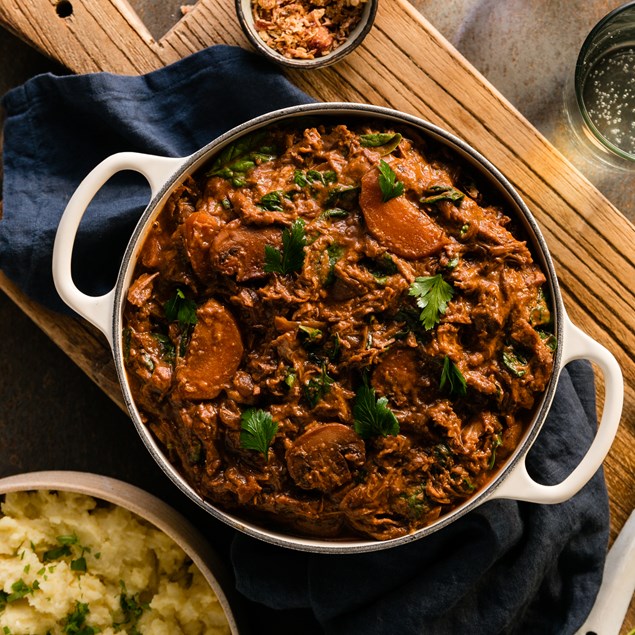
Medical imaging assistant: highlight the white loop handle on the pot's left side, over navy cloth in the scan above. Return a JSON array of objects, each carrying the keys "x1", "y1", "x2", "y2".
[{"x1": 53, "y1": 152, "x2": 186, "y2": 347}]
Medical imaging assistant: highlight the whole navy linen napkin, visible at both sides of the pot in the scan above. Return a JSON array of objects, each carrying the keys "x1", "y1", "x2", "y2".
[{"x1": 0, "y1": 46, "x2": 608, "y2": 635}]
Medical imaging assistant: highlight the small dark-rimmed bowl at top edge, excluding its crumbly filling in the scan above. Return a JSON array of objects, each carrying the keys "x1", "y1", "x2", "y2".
[{"x1": 235, "y1": 0, "x2": 379, "y2": 69}]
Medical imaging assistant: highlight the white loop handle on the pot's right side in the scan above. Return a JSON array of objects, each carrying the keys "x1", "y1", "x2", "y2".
[{"x1": 491, "y1": 318, "x2": 624, "y2": 504}]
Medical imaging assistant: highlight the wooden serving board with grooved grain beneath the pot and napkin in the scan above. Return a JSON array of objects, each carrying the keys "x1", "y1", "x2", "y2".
[{"x1": 0, "y1": 0, "x2": 635, "y2": 624}]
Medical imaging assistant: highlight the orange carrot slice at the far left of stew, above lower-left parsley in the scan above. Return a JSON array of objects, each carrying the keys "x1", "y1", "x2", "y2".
[{"x1": 175, "y1": 300, "x2": 243, "y2": 399}]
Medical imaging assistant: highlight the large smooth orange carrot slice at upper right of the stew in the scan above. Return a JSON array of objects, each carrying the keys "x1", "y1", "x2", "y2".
[{"x1": 359, "y1": 167, "x2": 447, "y2": 258}]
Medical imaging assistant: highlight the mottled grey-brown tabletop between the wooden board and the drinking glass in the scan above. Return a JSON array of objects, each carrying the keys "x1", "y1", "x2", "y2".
[{"x1": 412, "y1": 0, "x2": 635, "y2": 222}]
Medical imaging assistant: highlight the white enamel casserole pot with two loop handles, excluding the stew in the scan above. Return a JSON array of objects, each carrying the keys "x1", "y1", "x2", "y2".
[{"x1": 53, "y1": 103, "x2": 624, "y2": 553}]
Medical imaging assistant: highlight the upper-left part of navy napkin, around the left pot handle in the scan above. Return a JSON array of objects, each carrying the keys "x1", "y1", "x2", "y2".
[{"x1": 0, "y1": 46, "x2": 313, "y2": 312}]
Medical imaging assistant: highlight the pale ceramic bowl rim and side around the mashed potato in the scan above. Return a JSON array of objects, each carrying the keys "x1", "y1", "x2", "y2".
[{"x1": 0, "y1": 471, "x2": 246, "y2": 635}]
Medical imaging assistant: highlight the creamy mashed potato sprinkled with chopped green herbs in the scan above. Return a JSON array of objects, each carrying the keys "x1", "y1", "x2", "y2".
[{"x1": 0, "y1": 491, "x2": 229, "y2": 635}]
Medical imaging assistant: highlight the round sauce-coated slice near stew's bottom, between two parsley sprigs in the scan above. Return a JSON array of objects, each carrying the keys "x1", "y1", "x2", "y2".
[{"x1": 286, "y1": 423, "x2": 366, "y2": 492}]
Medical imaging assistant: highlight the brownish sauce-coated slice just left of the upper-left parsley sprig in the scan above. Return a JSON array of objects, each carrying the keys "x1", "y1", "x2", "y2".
[{"x1": 211, "y1": 219, "x2": 282, "y2": 282}]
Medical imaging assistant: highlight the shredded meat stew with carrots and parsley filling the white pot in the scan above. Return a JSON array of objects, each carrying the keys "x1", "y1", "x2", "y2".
[{"x1": 123, "y1": 119, "x2": 556, "y2": 540}]
